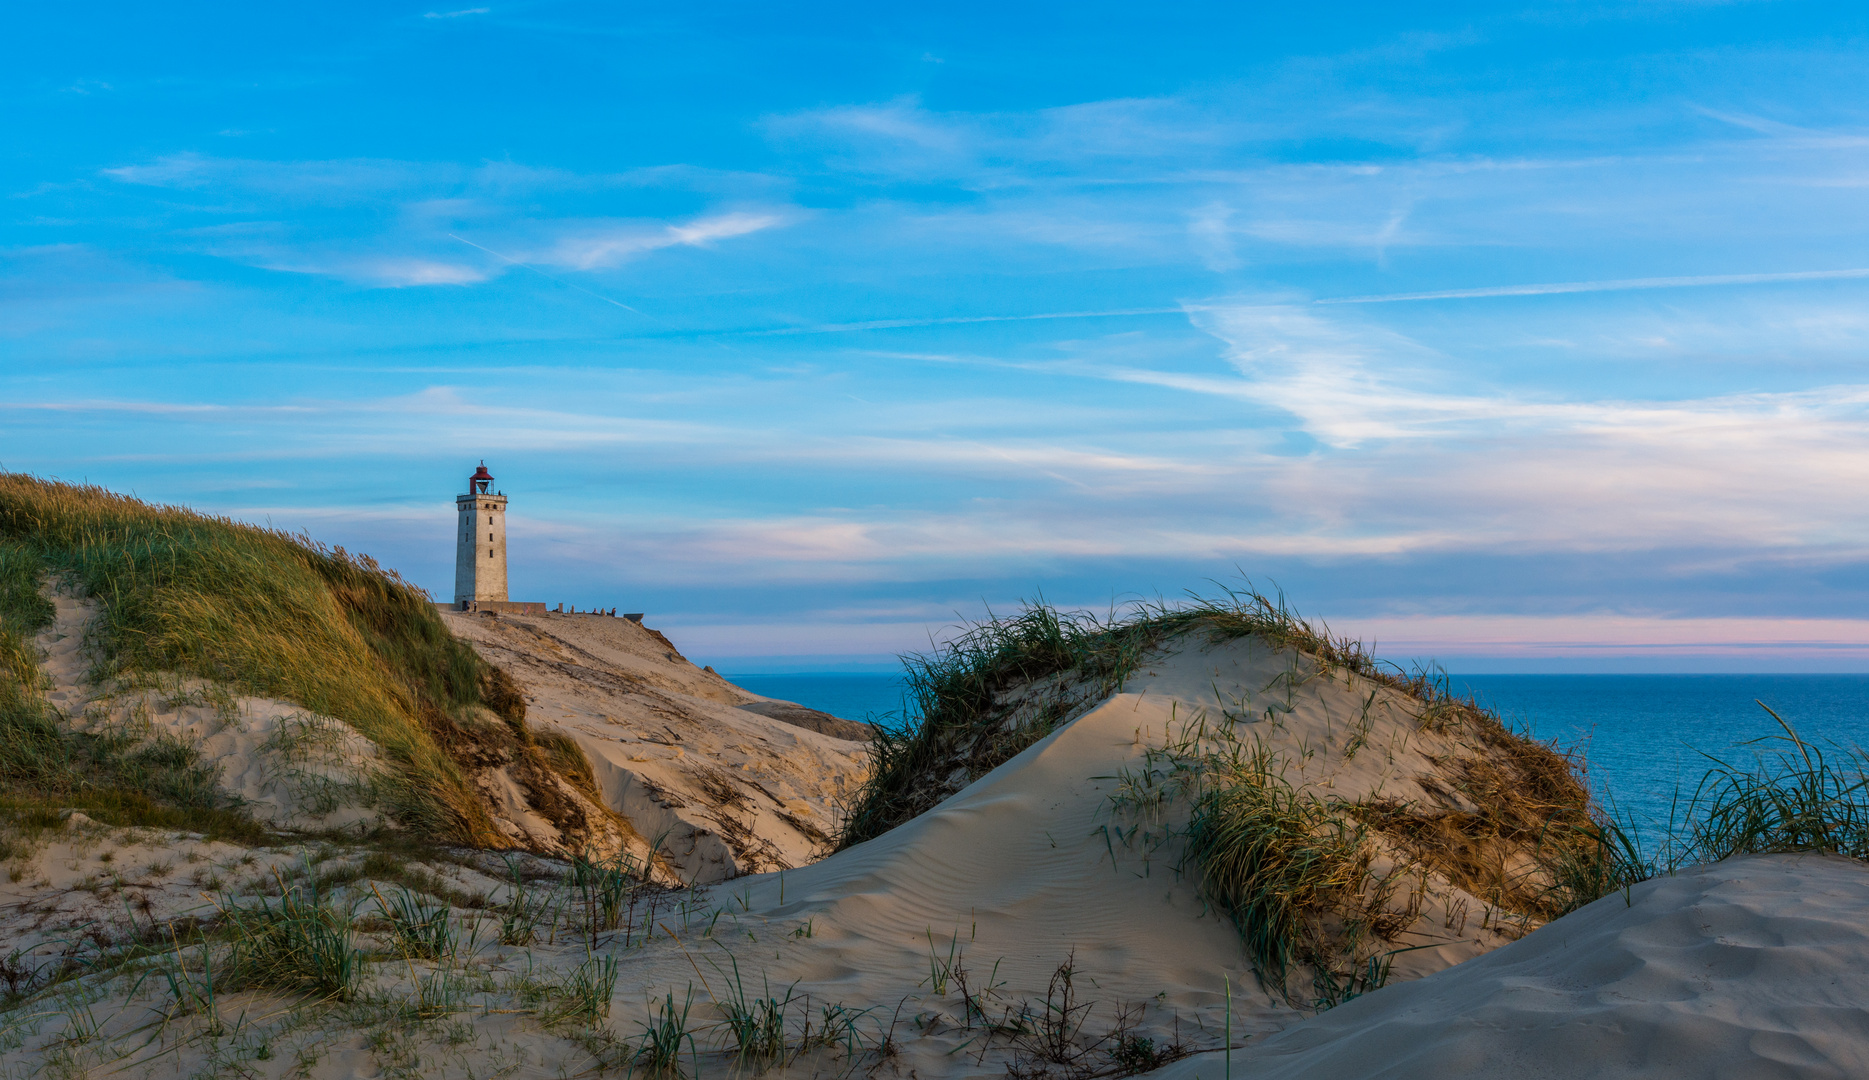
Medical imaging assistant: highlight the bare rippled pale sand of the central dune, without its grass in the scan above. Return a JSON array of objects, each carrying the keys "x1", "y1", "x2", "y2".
[{"x1": 590, "y1": 639, "x2": 1569, "y2": 1074}]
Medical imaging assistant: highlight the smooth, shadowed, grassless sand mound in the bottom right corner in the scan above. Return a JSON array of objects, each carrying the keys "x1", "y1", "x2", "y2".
[{"x1": 1161, "y1": 856, "x2": 1869, "y2": 1080}]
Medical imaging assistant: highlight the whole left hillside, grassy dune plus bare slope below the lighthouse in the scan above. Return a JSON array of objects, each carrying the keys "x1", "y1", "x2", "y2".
[{"x1": 0, "y1": 475, "x2": 869, "y2": 882}]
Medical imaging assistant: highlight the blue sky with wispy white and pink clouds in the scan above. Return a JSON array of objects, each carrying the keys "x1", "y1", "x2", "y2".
[{"x1": 0, "y1": 0, "x2": 1869, "y2": 673}]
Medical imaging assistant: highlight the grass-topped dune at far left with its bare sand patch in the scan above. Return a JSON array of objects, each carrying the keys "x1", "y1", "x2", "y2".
[{"x1": 0, "y1": 475, "x2": 647, "y2": 856}]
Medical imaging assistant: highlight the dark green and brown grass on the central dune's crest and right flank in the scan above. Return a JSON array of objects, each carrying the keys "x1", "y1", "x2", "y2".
[{"x1": 839, "y1": 589, "x2": 1622, "y2": 1007}]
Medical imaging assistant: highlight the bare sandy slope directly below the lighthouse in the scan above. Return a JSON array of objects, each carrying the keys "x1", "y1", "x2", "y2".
[{"x1": 443, "y1": 611, "x2": 867, "y2": 882}]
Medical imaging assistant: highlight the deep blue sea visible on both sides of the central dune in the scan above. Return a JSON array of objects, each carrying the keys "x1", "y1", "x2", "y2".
[{"x1": 729, "y1": 673, "x2": 1869, "y2": 835}]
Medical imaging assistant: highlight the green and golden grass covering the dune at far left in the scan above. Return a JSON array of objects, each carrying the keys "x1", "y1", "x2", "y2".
[{"x1": 0, "y1": 475, "x2": 548, "y2": 846}]
